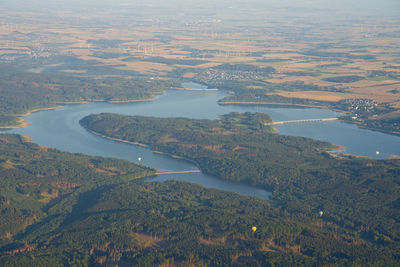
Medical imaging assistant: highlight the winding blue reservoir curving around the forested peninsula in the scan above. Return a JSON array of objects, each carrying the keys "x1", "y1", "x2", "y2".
[{"x1": 9, "y1": 87, "x2": 400, "y2": 199}]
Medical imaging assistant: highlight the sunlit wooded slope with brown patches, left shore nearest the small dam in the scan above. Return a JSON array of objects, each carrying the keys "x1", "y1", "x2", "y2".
[{"x1": 0, "y1": 135, "x2": 155, "y2": 240}]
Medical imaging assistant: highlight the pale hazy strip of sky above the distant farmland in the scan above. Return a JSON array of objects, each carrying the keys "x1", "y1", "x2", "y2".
[{"x1": 0, "y1": 0, "x2": 400, "y2": 16}]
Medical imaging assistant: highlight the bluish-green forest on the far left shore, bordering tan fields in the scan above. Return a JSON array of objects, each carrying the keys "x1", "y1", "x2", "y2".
[{"x1": 0, "y1": 65, "x2": 173, "y2": 129}]
